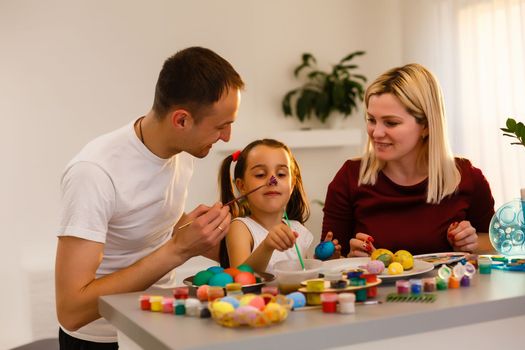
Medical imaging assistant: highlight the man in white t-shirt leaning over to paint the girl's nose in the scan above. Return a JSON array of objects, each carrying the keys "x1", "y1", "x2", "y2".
[{"x1": 55, "y1": 47, "x2": 244, "y2": 349}]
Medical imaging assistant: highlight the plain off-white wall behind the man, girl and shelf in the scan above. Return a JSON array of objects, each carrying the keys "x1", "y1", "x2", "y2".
[{"x1": 0, "y1": 0, "x2": 402, "y2": 348}]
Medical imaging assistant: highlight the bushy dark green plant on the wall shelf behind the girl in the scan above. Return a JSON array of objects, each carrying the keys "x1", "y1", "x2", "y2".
[{"x1": 282, "y1": 51, "x2": 366, "y2": 123}]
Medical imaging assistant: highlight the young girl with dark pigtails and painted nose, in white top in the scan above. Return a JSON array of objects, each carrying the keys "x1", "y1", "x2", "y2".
[{"x1": 219, "y1": 139, "x2": 340, "y2": 272}]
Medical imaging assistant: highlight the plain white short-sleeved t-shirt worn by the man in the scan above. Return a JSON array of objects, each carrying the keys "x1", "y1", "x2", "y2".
[{"x1": 58, "y1": 122, "x2": 194, "y2": 342}]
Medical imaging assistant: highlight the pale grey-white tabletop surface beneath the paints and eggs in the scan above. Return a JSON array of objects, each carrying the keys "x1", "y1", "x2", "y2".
[{"x1": 99, "y1": 270, "x2": 525, "y2": 350}]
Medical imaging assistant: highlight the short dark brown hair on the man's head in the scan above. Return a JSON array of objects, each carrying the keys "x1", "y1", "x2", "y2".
[{"x1": 153, "y1": 47, "x2": 244, "y2": 116}]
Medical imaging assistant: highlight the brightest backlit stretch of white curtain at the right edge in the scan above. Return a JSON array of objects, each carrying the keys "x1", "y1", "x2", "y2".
[{"x1": 453, "y1": 0, "x2": 525, "y2": 206}]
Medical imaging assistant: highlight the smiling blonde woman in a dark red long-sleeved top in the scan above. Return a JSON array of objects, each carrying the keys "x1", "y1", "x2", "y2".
[{"x1": 323, "y1": 64, "x2": 494, "y2": 256}]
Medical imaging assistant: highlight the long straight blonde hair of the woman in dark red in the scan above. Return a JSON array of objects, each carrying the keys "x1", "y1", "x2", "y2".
[{"x1": 359, "y1": 63, "x2": 461, "y2": 203}]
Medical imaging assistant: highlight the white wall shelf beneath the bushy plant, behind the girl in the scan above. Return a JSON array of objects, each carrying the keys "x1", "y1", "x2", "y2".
[{"x1": 213, "y1": 129, "x2": 361, "y2": 152}]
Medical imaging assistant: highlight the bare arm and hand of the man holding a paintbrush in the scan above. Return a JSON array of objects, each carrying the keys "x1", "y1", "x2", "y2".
[{"x1": 55, "y1": 204, "x2": 231, "y2": 331}]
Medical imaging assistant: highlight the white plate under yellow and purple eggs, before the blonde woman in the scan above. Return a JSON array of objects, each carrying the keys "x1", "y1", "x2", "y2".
[{"x1": 321, "y1": 258, "x2": 434, "y2": 281}]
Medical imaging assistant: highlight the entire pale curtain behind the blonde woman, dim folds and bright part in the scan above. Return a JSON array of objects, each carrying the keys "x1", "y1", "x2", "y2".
[{"x1": 401, "y1": 0, "x2": 525, "y2": 209}]
